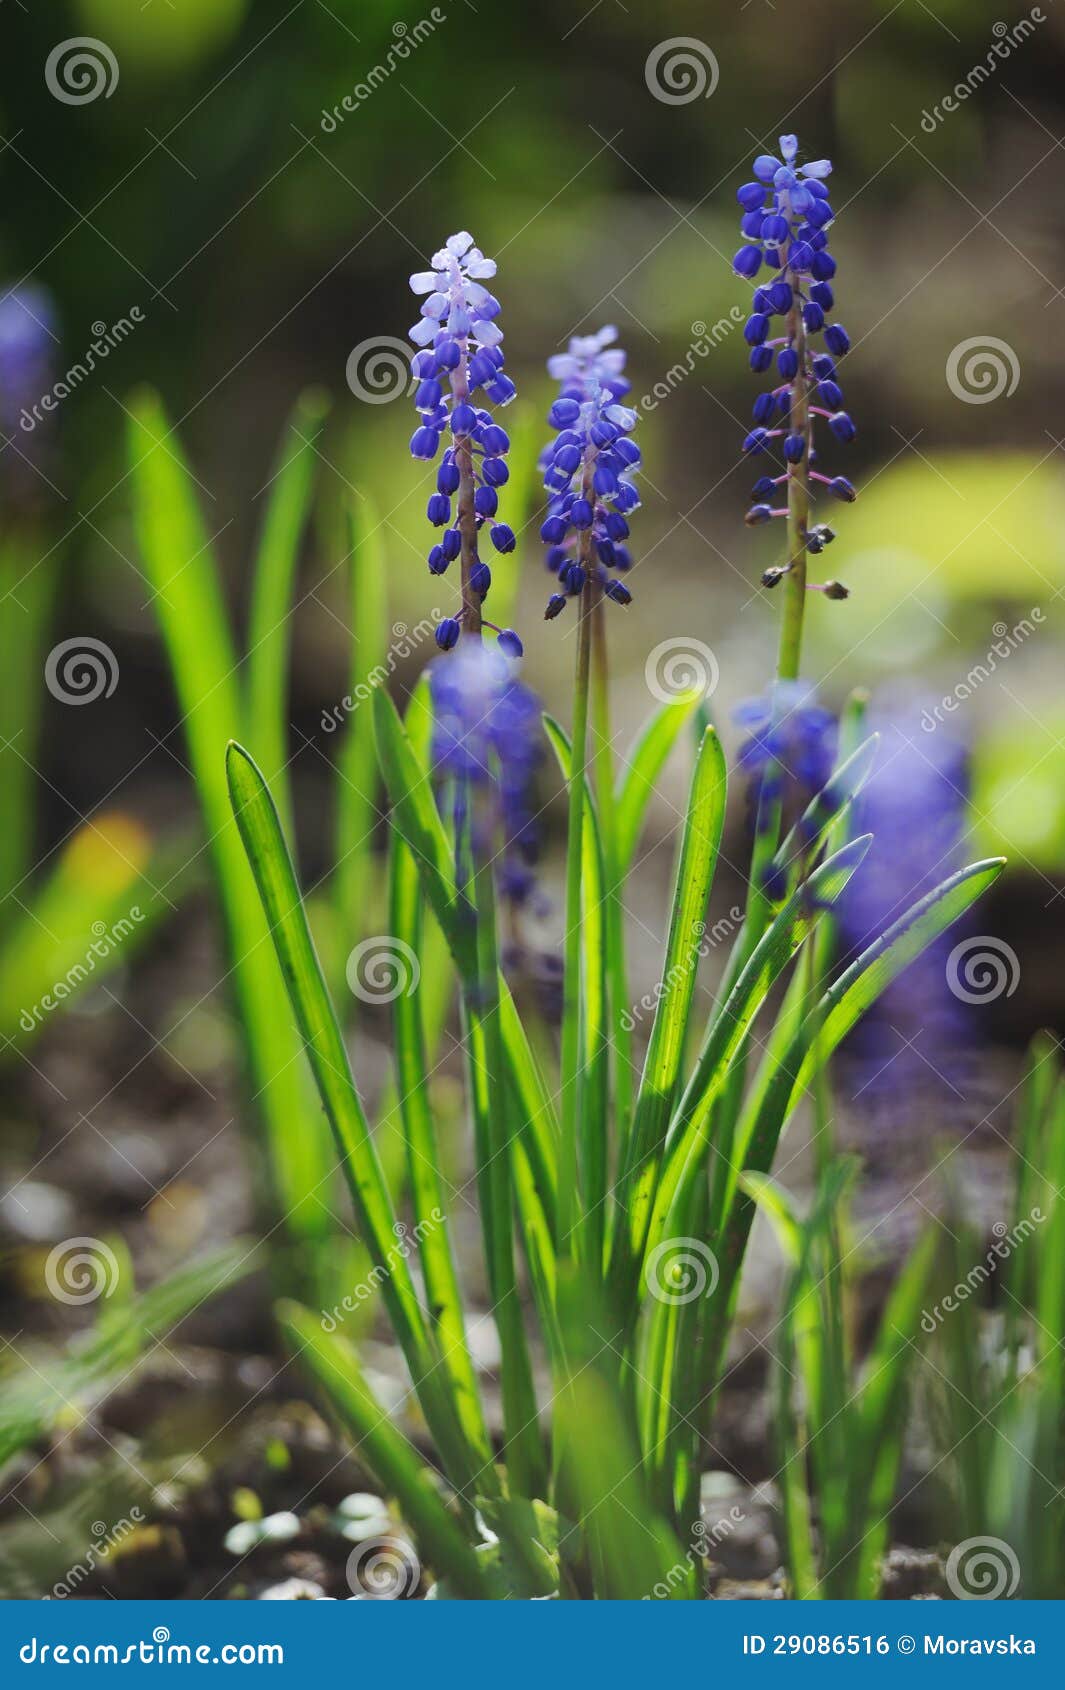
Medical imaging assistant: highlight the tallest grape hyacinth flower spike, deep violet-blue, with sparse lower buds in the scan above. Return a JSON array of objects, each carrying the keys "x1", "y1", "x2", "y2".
[{"x1": 732, "y1": 135, "x2": 857, "y2": 645}]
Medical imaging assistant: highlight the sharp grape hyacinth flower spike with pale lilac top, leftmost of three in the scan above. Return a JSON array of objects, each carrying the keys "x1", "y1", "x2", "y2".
[{"x1": 411, "y1": 230, "x2": 521, "y2": 656}]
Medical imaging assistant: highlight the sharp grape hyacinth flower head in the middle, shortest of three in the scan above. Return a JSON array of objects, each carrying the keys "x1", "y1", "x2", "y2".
[{"x1": 539, "y1": 326, "x2": 641, "y2": 620}]
